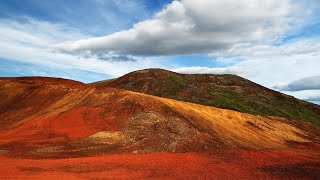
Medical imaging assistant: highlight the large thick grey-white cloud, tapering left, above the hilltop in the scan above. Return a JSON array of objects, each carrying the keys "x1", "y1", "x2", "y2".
[{"x1": 54, "y1": 0, "x2": 297, "y2": 56}]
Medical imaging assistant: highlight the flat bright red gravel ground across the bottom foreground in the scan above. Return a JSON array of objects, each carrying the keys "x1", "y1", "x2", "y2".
[{"x1": 0, "y1": 149, "x2": 320, "y2": 179}]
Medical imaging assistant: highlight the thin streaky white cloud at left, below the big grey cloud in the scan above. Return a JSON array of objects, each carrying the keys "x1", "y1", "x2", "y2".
[{"x1": 0, "y1": 17, "x2": 162, "y2": 82}]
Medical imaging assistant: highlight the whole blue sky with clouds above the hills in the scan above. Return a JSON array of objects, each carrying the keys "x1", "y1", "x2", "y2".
[{"x1": 0, "y1": 0, "x2": 320, "y2": 104}]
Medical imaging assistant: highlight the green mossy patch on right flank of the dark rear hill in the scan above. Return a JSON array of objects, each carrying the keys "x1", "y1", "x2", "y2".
[{"x1": 209, "y1": 89, "x2": 320, "y2": 126}]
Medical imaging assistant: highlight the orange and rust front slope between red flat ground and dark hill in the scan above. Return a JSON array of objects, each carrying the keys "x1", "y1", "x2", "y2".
[{"x1": 0, "y1": 78, "x2": 319, "y2": 155}]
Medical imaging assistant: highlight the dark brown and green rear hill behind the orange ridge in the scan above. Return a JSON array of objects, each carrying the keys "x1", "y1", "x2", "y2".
[{"x1": 93, "y1": 69, "x2": 320, "y2": 126}]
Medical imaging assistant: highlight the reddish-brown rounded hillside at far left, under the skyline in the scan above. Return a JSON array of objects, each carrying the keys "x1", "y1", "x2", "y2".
[{"x1": 0, "y1": 77, "x2": 87, "y2": 130}]
